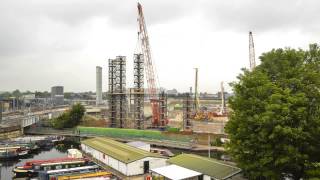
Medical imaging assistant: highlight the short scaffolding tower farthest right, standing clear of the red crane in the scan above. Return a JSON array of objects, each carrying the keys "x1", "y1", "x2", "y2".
[{"x1": 183, "y1": 93, "x2": 192, "y2": 131}]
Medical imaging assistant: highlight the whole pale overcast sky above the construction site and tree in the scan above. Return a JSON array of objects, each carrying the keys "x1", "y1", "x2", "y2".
[{"x1": 0, "y1": 0, "x2": 320, "y2": 92}]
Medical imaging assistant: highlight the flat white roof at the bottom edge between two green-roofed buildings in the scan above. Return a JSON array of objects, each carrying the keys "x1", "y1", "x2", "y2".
[{"x1": 151, "y1": 165, "x2": 202, "y2": 180}]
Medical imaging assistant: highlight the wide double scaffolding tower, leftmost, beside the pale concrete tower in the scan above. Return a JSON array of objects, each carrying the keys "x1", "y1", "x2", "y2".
[{"x1": 108, "y1": 56, "x2": 127, "y2": 128}]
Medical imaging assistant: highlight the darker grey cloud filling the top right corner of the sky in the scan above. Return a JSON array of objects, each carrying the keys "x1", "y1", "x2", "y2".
[{"x1": 203, "y1": 0, "x2": 320, "y2": 32}]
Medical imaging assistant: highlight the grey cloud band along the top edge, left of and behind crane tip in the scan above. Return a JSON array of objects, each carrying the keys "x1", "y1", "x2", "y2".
[{"x1": 7, "y1": 0, "x2": 193, "y2": 26}]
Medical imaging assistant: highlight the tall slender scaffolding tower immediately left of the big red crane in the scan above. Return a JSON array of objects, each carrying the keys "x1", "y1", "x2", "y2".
[{"x1": 132, "y1": 54, "x2": 144, "y2": 129}]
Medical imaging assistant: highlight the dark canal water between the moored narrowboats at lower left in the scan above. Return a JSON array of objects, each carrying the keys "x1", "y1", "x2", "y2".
[{"x1": 0, "y1": 142, "x2": 74, "y2": 180}]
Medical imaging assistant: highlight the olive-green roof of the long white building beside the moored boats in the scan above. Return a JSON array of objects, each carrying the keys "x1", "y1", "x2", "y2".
[{"x1": 82, "y1": 137, "x2": 164, "y2": 164}]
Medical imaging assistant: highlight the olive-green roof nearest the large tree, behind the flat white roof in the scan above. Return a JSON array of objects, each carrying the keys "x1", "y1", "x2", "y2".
[{"x1": 168, "y1": 154, "x2": 241, "y2": 179}]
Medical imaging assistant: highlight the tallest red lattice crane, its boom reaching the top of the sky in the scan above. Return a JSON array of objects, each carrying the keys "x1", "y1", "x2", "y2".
[{"x1": 138, "y1": 3, "x2": 167, "y2": 127}]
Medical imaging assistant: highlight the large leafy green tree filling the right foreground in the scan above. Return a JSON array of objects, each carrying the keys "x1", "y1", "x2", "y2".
[{"x1": 226, "y1": 44, "x2": 320, "y2": 179}]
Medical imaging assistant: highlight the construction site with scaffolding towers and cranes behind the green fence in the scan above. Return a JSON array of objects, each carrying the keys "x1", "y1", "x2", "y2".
[{"x1": 102, "y1": 3, "x2": 255, "y2": 135}]
